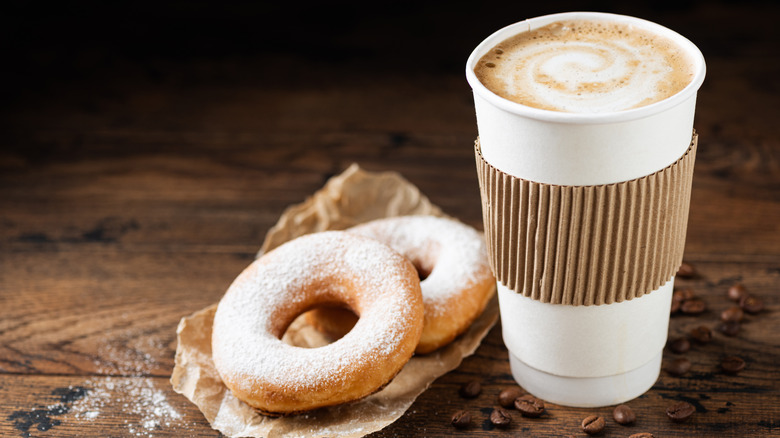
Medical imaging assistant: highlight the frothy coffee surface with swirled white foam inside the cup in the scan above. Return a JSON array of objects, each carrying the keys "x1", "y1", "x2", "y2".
[{"x1": 474, "y1": 20, "x2": 694, "y2": 113}]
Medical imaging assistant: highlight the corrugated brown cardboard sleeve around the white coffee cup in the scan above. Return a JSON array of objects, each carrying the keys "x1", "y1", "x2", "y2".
[{"x1": 475, "y1": 132, "x2": 698, "y2": 306}]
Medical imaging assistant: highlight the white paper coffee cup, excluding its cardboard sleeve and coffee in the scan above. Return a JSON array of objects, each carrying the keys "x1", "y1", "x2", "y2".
[{"x1": 466, "y1": 12, "x2": 705, "y2": 407}]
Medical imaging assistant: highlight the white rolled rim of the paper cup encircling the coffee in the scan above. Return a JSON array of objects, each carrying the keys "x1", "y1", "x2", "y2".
[{"x1": 466, "y1": 11, "x2": 706, "y2": 124}]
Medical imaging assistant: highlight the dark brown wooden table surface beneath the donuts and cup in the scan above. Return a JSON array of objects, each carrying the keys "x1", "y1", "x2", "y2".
[{"x1": 0, "y1": 0, "x2": 780, "y2": 437}]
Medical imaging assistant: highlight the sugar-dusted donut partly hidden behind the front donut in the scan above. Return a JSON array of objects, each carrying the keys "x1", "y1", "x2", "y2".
[{"x1": 306, "y1": 216, "x2": 496, "y2": 353}]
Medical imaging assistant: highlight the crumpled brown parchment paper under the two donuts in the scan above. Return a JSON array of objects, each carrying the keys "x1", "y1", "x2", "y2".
[{"x1": 171, "y1": 164, "x2": 498, "y2": 438}]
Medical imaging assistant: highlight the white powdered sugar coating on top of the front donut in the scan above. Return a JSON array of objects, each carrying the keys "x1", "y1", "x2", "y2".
[{"x1": 213, "y1": 231, "x2": 424, "y2": 391}]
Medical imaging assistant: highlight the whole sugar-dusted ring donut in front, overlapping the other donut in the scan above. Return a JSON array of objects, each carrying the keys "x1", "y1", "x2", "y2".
[{"x1": 212, "y1": 231, "x2": 423, "y2": 414}]
